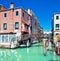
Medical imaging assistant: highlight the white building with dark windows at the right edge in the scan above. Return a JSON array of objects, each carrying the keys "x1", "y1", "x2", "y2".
[{"x1": 52, "y1": 13, "x2": 60, "y2": 43}]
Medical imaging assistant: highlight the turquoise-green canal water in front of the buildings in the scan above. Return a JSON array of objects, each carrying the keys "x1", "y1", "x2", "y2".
[{"x1": 0, "y1": 43, "x2": 60, "y2": 61}]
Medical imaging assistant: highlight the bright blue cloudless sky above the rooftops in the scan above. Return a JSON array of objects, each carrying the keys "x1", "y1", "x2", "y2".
[{"x1": 0, "y1": 0, "x2": 60, "y2": 30}]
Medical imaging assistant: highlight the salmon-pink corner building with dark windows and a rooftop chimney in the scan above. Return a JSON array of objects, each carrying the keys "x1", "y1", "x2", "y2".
[{"x1": 0, "y1": 3, "x2": 30, "y2": 42}]
